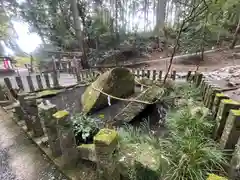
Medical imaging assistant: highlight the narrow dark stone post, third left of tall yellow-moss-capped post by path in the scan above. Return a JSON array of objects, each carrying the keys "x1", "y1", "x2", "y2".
[{"x1": 18, "y1": 93, "x2": 32, "y2": 131}]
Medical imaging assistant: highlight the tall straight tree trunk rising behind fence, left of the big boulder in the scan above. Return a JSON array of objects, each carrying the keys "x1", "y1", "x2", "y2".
[{"x1": 70, "y1": 0, "x2": 89, "y2": 69}]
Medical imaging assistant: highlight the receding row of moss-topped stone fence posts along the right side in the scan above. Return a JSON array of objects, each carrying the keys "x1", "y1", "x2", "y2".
[{"x1": 191, "y1": 72, "x2": 240, "y2": 180}]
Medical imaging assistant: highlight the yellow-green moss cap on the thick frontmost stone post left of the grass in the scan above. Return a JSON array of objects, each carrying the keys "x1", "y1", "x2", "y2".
[{"x1": 93, "y1": 129, "x2": 118, "y2": 145}]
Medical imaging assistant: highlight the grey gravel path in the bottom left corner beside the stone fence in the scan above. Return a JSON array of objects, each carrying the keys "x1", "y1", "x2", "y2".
[{"x1": 0, "y1": 107, "x2": 67, "y2": 180}]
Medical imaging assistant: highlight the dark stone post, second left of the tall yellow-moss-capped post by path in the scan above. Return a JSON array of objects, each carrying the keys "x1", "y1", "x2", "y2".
[{"x1": 24, "y1": 96, "x2": 44, "y2": 137}]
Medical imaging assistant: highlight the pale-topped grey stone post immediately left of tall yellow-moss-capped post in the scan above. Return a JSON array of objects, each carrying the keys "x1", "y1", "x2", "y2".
[{"x1": 38, "y1": 102, "x2": 62, "y2": 157}]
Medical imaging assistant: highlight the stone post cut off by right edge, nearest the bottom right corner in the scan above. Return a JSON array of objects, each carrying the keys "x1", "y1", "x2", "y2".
[{"x1": 228, "y1": 138, "x2": 240, "y2": 180}]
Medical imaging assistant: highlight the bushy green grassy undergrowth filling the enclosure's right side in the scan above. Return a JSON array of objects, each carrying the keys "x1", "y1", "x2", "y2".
[{"x1": 119, "y1": 83, "x2": 227, "y2": 180}]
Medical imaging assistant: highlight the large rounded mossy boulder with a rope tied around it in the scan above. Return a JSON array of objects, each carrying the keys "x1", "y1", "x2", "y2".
[{"x1": 81, "y1": 68, "x2": 135, "y2": 113}]
